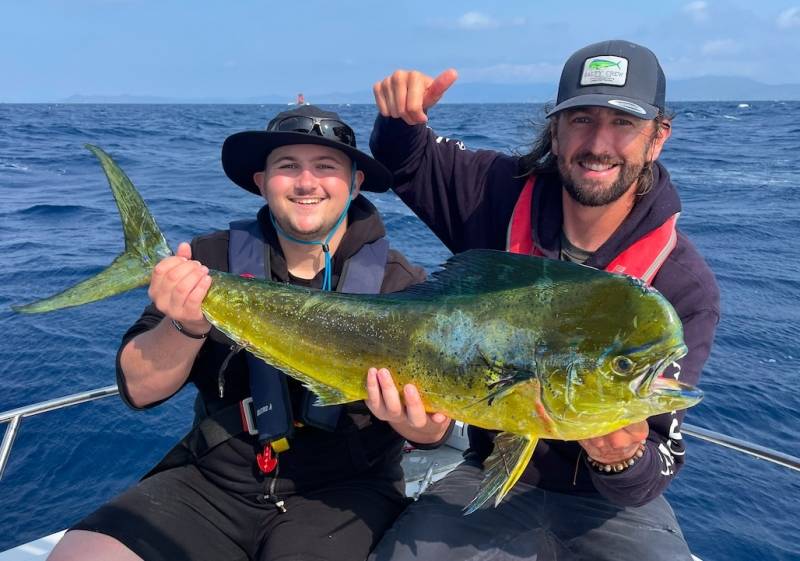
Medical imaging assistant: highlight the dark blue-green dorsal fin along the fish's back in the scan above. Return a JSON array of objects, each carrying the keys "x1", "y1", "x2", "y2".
[{"x1": 401, "y1": 249, "x2": 596, "y2": 298}]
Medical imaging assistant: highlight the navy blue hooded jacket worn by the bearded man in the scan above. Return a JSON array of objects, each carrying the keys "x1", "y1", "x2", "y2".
[{"x1": 370, "y1": 116, "x2": 719, "y2": 505}]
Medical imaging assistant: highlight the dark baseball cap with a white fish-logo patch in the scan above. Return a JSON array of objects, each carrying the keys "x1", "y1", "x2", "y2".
[{"x1": 547, "y1": 40, "x2": 667, "y2": 119}]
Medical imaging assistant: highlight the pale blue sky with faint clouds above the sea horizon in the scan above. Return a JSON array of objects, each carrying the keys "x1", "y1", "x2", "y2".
[{"x1": 0, "y1": 0, "x2": 800, "y2": 102}]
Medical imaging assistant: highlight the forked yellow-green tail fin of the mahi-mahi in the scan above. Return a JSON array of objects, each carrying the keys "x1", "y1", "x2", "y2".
[{"x1": 11, "y1": 144, "x2": 172, "y2": 314}]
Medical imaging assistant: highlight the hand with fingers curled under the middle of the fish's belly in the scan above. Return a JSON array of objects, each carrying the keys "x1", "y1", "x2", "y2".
[{"x1": 364, "y1": 368, "x2": 450, "y2": 444}]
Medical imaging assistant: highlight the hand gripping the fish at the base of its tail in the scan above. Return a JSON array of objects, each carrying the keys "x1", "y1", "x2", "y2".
[{"x1": 147, "y1": 242, "x2": 211, "y2": 334}]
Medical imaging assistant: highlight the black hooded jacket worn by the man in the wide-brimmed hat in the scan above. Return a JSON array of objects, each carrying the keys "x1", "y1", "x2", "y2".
[{"x1": 117, "y1": 196, "x2": 425, "y2": 494}]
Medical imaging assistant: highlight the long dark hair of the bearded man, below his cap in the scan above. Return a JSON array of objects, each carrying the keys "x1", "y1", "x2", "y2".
[{"x1": 519, "y1": 106, "x2": 673, "y2": 196}]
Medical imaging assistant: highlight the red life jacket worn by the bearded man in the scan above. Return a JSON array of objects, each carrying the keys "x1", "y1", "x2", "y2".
[{"x1": 506, "y1": 175, "x2": 680, "y2": 284}]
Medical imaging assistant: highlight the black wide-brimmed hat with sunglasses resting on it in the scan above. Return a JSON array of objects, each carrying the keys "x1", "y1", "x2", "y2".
[{"x1": 222, "y1": 105, "x2": 392, "y2": 195}]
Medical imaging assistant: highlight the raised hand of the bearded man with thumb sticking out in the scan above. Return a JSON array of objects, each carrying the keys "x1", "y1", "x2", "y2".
[{"x1": 372, "y1": 68, "x2": 458, "y2": 125}]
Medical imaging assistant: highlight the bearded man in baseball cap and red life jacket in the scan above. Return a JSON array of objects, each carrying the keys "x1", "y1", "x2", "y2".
[{"x1": 371, "y1": 41, "x2": 719, "y2": 561}]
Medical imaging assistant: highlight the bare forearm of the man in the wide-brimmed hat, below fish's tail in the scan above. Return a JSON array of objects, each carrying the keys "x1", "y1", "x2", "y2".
[{"x1": 119, "y1": 318, "x2": 205, "y2": 407}]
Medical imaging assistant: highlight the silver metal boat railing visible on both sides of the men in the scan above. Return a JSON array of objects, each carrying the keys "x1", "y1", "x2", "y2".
[{"x1": 0, "y1": 385, "x2": 800, "y2": 480}]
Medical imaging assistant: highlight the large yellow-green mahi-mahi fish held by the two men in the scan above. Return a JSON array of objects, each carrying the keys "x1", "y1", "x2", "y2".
[{"x1": 14, "y1": 145, "x2": 702, "y2": 512}]
